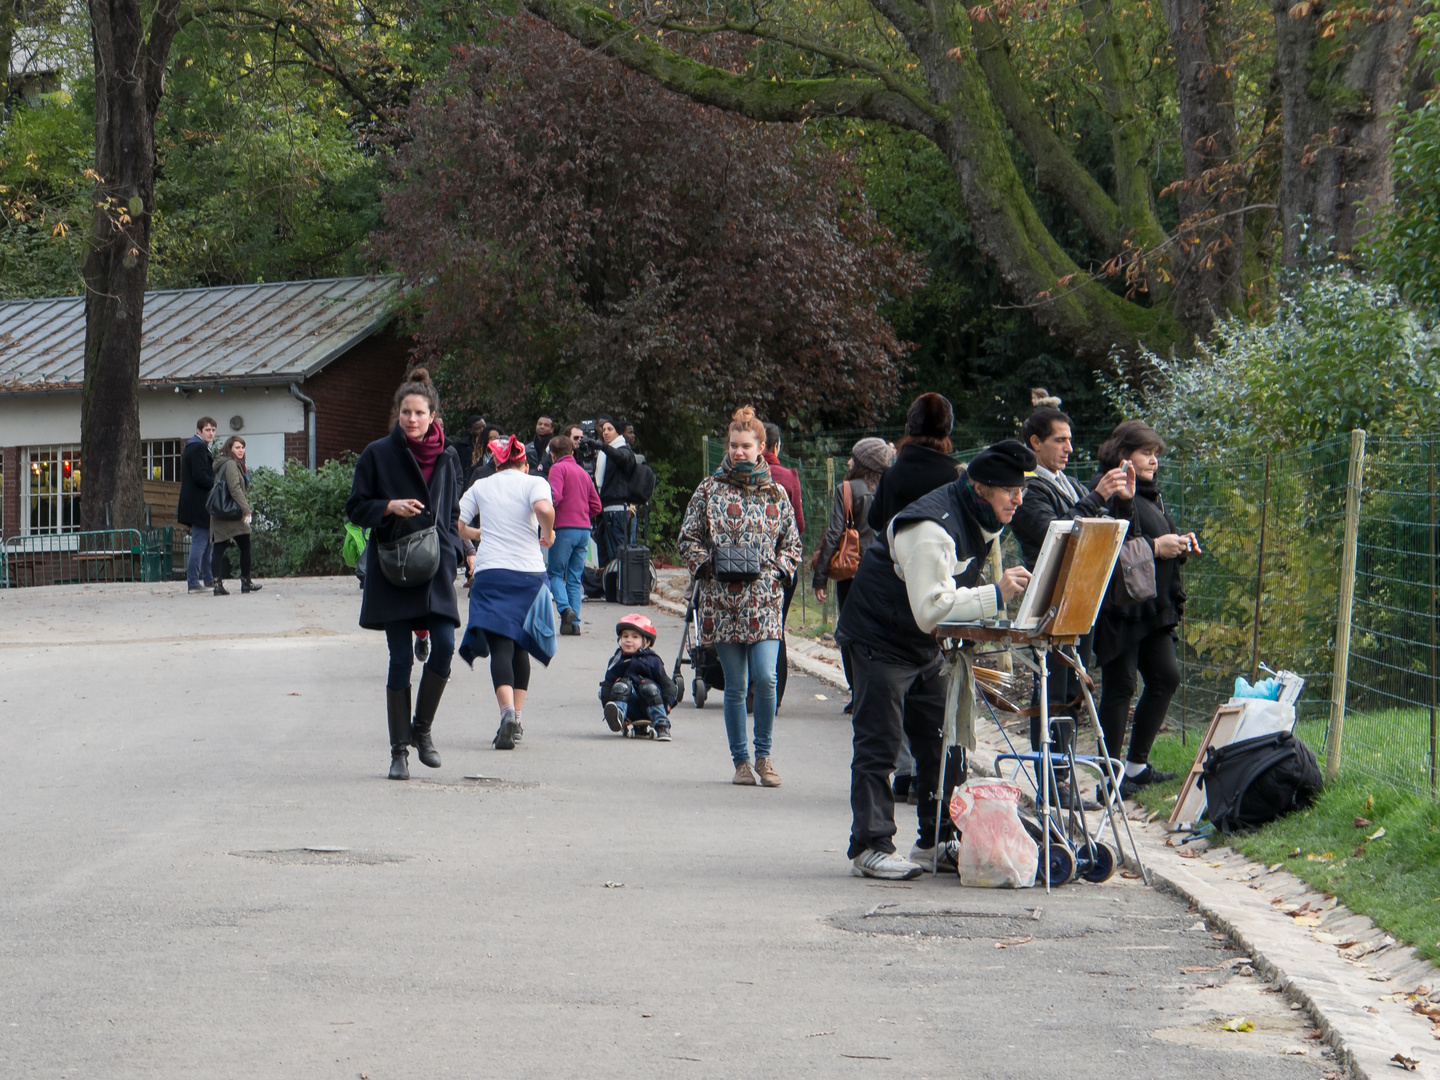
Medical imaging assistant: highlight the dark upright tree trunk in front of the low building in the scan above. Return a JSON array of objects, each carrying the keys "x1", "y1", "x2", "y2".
[{"x1": 81, "y1": 0, "x2": 179, "y2": 528}]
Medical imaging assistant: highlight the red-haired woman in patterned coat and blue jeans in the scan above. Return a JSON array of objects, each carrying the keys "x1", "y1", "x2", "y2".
[{"x1": 680, "y1": 406, "x2": 801, "y2": 788}]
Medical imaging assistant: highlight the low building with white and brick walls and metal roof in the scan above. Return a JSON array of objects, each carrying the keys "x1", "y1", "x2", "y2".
[{"x1": 0, "y1": 278, "x2": 410, "y2": 537}]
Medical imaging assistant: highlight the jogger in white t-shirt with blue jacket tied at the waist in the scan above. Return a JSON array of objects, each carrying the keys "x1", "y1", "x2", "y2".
[{"x1": 458, "y1": 435, "x2": 556, "y2": 750}]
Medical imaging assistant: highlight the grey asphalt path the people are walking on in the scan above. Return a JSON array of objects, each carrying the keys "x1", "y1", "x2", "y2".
[{"x1": 0, "y1": 580, "x2": 1338, "y2": 1080}]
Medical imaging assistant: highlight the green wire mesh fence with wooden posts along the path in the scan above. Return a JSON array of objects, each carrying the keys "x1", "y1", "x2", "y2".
[{"x1": 706, "y1": 432, "x2": 1440, "y2": 798}]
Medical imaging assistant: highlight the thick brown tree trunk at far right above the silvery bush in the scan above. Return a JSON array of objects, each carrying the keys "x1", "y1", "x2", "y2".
[{"x1": 1273, "y1": 0, "x2": 1420, "y2": 266}]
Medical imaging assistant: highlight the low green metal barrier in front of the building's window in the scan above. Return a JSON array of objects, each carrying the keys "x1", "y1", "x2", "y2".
[{"x1": 0, "y1": 526, "x2": 174, "y2": 589}]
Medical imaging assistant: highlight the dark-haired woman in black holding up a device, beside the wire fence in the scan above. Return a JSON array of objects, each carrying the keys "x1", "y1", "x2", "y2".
[{"x1": 1094, "y1": 420, "x2": 1200, "y2": 799}]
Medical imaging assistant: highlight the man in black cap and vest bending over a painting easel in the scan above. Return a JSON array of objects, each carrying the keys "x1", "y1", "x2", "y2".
[{"x1": 835, "y1": 439, "x2": 1035, "y2": 878}]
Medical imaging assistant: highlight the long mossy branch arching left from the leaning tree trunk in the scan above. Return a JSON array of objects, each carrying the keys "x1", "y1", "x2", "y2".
[{"x1": 524, "y1": 0, "x2": 939, "y2": 138}]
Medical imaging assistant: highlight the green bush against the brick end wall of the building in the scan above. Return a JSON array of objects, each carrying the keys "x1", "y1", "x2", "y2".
[{"x1": 251, "y1": 454, "x2": 356, "y2": 577}]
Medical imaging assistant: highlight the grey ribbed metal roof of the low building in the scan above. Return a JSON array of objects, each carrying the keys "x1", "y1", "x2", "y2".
[{"x1": 0, "y1": 276, "x2": 399, "y2": 392}]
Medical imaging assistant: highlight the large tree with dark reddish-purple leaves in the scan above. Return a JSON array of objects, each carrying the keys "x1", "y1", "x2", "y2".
[{"x1": 376, "y1": 16, "x2": 923, "y2": 445}]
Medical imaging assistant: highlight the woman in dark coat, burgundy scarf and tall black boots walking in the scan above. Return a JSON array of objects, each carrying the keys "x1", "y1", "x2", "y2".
[{"x1": 346, "y1": 367, "x2": 464, "y2": 780}]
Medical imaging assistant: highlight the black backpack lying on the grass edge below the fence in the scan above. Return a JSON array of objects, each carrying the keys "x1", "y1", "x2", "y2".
[{"x1": 1200, "y1": 732, "x2": 1323, "y2": 834}]
